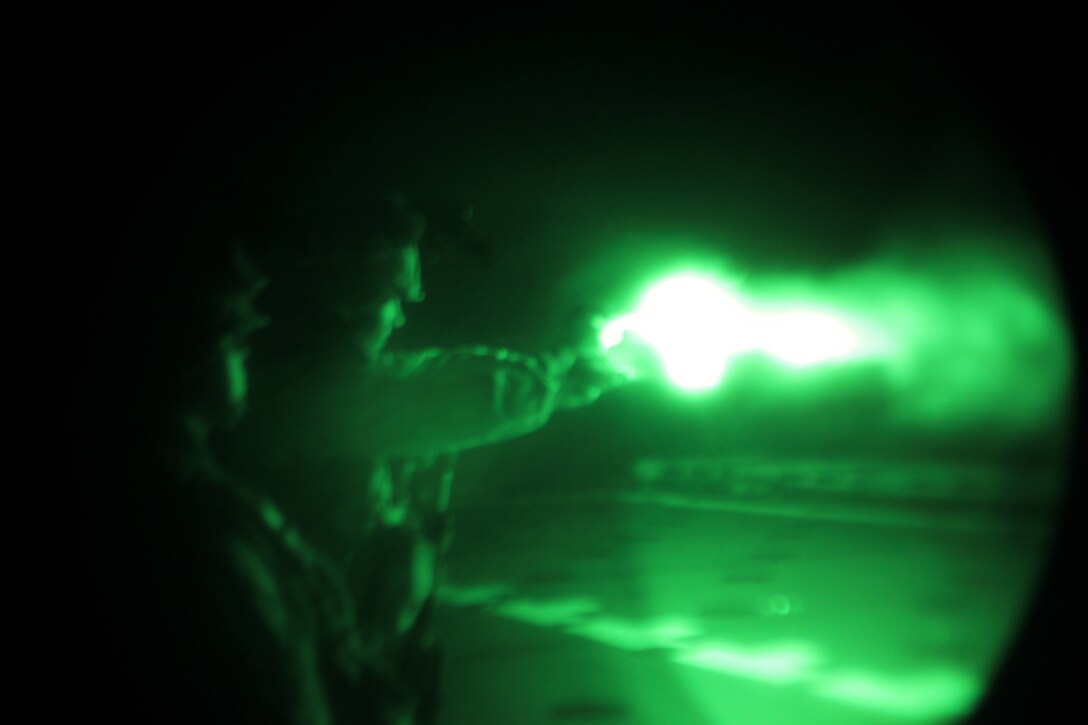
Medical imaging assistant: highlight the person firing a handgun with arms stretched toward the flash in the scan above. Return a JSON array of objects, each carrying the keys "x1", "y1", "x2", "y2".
[{"x1": 230, "y1": 189, "x2": 621, "y2": 723}]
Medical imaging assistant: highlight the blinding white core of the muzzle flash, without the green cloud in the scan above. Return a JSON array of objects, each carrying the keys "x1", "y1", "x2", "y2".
[{"x1": 599, "y1": 272, "x2": 873, "y2": 391}]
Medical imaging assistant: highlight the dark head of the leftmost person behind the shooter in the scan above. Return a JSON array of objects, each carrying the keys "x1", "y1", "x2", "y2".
[{"x1": 99, "y1": 230, "x2": 267, "y2": 468}]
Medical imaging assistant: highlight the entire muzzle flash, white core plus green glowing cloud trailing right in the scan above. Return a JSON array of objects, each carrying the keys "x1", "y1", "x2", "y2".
[{"x1": 598, "y1": 246, "x2": 1074, "y2": 432}]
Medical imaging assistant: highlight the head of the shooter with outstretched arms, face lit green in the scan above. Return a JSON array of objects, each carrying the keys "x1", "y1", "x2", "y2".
[{"x1": 253, "y1": 195, "x2": 425, "y2": 357}]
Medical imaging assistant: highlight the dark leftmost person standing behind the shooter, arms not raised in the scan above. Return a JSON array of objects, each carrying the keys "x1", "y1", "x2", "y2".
[{"x1": 78, "y1": 223, "x2": 409, "y2": 725}]
